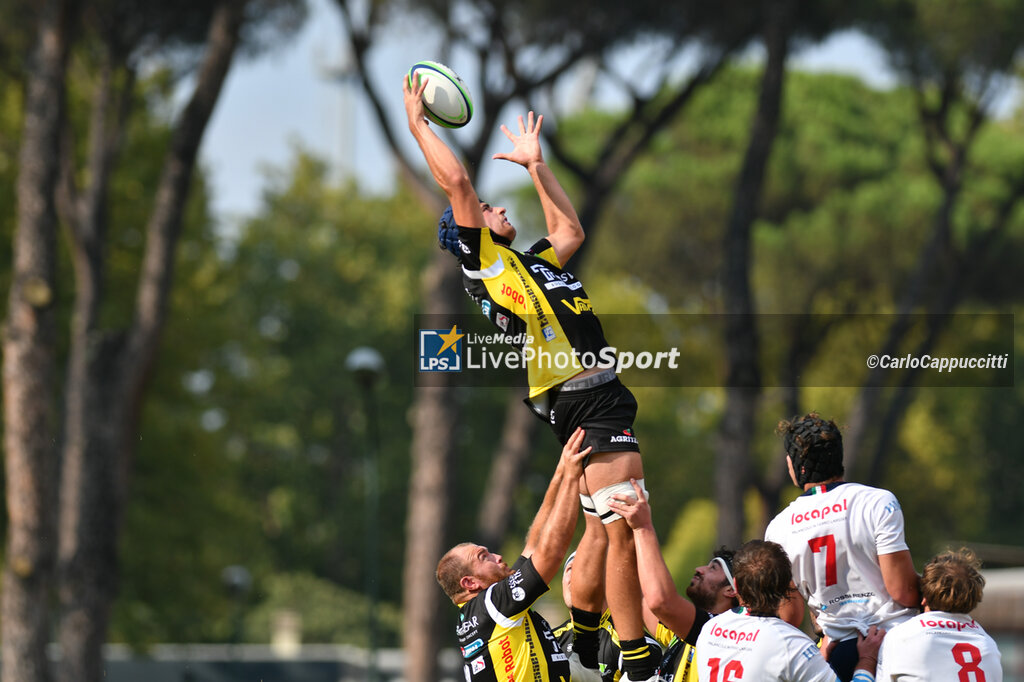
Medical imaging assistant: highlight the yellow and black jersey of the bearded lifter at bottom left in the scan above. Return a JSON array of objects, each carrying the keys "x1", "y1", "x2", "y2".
[{"x1": 456, "y1": 557, "x2": 569, "y2": 682}]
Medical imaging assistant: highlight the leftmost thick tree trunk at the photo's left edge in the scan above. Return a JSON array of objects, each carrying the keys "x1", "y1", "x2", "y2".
[{"x1": 0, "y1": 0, "x2": 76, "y2": 682}]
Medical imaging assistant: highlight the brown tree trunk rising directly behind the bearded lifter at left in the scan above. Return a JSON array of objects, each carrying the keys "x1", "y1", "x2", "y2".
[{"x1": 402, "y1": 251, "x2": 464, "y2": 682}]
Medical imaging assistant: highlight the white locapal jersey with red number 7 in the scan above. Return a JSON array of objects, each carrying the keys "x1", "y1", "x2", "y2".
[{"x1": 765, "y1": 482, "x2": 916, "y2": 641}]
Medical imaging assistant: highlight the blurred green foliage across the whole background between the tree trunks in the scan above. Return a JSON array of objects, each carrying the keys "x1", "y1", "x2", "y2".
[{"x1": 0, "y1": 13, "x2": 1024, "y2": 648}]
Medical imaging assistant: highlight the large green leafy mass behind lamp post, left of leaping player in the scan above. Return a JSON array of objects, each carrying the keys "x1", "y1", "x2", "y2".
[{"x1": 196, "y1": 156, "x2": 432, "y2": 594}]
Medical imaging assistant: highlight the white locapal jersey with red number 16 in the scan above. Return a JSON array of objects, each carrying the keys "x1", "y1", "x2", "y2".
[{"x1": 696, "y1": 609, "x2": 838, "y2": 682}]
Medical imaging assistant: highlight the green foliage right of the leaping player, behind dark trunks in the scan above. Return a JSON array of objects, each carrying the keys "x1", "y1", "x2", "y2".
[{"x1": 581, "y1": 63, "x2": 1024, "y2": 552}]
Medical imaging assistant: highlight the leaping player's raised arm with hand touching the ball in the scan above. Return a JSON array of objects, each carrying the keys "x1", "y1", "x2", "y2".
[{"x1": 401, "y1": 74, "x2": 484, "y2": 227}]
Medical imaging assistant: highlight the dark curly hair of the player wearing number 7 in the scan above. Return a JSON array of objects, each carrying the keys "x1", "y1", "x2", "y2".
[{"x1": 775, "y1": 412, "x2": 846, "y2": 487}]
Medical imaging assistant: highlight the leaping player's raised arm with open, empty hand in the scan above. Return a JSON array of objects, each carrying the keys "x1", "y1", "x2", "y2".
[{"x1": 493, "y1": 112, "x2": 585, "y2": 265}]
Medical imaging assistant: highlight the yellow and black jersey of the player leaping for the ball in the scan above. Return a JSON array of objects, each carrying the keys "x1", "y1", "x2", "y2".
[{"x1": 459, "y1": 226, "x2": 607, "y2": 398}]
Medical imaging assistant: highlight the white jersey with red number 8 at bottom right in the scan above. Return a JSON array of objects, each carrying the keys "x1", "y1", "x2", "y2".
[{"x1": 876, "y1": 611, "x2": 1002, "y2": 682}]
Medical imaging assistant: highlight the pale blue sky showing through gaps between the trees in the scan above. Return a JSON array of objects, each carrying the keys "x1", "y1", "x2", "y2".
[{"x1": 201, "y1": 0, "x2": 891, "y2": 220}]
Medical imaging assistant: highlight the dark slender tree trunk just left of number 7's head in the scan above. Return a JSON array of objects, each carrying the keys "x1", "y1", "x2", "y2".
[{"x1": 715, "y1": 0, "x2": 794, "y2": 547}]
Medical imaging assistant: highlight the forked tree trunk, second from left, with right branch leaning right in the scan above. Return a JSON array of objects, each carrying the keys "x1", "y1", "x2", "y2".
[{"x1": 58, "y1": 5, "x2": 246, "y2": 682}]
